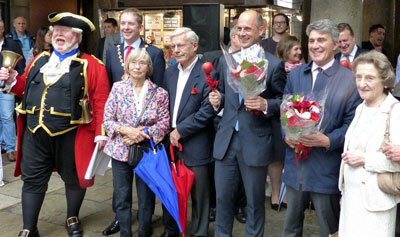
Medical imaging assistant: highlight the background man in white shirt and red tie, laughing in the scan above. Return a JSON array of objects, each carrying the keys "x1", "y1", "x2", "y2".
[{"x1": 335, "y1": 23, "x2": 368, "y2": 66}]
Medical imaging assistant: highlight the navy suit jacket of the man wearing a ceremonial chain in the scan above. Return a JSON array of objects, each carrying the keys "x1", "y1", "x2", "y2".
[{"x1": 106, "y1": 40, "x2": 165, "y2": 88}]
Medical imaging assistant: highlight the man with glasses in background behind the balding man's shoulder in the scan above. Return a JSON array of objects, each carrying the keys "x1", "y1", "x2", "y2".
[{"x1": 260, "y1": 13, "x2": 289, "y2": 55}]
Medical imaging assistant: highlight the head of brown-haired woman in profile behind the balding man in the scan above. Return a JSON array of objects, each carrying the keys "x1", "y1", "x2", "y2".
[{"x1": 275, "y1": 35, "x2": 302, "y2": 74}]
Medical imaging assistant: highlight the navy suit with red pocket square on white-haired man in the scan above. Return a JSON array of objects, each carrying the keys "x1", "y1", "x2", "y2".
[{"x1": 164, "y1": 59, "x2": 214, "y2": 236}]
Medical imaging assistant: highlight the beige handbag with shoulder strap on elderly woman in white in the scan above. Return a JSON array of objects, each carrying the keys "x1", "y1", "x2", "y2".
[{"x1": 378, "y1": 102, "x2": 400, "y2": 196}]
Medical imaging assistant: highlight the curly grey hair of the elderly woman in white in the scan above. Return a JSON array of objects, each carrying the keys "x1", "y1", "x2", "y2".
[{"x1": 353, "y1": 50, "x2": 396, "y2": 94}]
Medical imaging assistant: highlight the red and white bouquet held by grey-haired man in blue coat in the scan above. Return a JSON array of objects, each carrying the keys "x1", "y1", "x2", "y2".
[{"x1": 281, "y1": 94, "x2": 325, "y2": 166}]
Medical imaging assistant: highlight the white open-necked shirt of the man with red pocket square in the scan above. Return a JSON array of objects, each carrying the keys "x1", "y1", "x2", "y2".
[{"x1": 172, "y1": 57, "x2": 199, "y2": 128}]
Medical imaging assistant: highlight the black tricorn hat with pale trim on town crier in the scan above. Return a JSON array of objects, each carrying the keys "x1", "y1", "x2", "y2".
[{"x1": 48, "y1": 12, "x2": 96, "y2": 31}]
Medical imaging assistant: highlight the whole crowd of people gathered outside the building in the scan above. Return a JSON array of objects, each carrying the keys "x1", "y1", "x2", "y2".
[{"x1": 0, "y1": 5, "x2": 400, "y2": 237}]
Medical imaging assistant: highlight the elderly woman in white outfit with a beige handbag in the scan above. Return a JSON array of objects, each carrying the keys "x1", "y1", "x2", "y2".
[{"x1": 339, "y1": 51, "x2": 400, "y2": 237}]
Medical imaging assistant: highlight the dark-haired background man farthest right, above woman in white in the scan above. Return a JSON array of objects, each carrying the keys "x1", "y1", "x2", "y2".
[{"x1": 361, "y1": 24, "x2": 387, "y2": 56}]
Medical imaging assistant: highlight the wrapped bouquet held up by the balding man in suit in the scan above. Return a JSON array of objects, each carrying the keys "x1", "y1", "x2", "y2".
[{"x1": 221, "y1": 44, "x2": 268, "y2": 99}]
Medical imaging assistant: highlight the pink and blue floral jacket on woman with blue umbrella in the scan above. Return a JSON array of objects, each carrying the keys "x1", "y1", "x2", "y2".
[{"x1": 103, "y1": 80, "x2": 170, "y2": 161}]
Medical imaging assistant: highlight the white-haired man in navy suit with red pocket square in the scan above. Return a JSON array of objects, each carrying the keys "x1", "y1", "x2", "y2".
[{"x1": 162, "y1": 27, "x2": 214, "y2": 237}]
